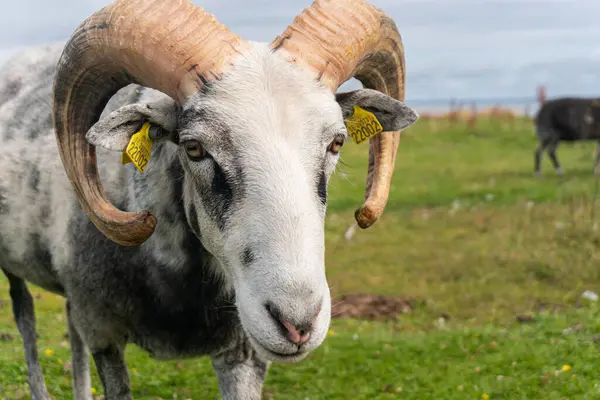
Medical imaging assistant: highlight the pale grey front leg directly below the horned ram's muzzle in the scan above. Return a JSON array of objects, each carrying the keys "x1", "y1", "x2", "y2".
[{"x1": 212, "y1": 341, "x2": 269, "y2": 400}]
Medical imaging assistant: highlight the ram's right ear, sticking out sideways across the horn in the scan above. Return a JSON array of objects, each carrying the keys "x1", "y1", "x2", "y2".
[{"x1": 335, "y1": 89, "x2": 419, "y2": 132}]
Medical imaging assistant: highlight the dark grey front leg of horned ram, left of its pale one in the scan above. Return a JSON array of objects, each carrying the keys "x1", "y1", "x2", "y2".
[{"x1": 92, "y1": 344, "x2": 133, "y2": 400}]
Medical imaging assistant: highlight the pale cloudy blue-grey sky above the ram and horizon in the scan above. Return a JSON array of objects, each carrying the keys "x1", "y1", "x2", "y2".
[{"x1": 0, "y1": 0, "x2": 600, "y2": 101}]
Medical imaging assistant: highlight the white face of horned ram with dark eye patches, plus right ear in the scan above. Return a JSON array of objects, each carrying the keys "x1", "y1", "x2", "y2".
[{"x1": 90, "y1": 45, "x2": 416, "y2": 362}]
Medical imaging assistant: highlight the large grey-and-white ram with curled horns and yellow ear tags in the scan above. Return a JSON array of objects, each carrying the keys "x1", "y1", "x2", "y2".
[{"x1": 0, "y1": 0, "x2": 417, "y2": 400}]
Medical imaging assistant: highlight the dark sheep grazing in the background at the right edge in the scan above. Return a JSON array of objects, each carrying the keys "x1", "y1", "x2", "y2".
[{"x1": 535, "y1": 98, "x2": 600, "y2": 176}]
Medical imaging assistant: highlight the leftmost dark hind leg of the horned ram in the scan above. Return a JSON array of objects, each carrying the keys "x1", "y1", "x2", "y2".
[{"x1": 2, "y1": 269, "x2": 51, "y2": 400}]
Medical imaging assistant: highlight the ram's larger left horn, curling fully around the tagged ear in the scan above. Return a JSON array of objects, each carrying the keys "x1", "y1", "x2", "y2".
[{"x1": 53, "y1": 0, "x2": 247, "y2": 246}]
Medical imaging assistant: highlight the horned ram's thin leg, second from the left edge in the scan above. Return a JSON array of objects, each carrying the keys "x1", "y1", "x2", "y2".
[{"x1": 67, "y1": 301, "x2": 92, "y2": 400}]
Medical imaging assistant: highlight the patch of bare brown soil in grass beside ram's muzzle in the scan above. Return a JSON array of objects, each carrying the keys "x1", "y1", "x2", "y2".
[{"x1": 331, "y1": 293, "x2": 412, "y2": 321}]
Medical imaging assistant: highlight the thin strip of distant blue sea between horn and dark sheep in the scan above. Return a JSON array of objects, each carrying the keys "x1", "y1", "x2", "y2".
[{"x1": 405, "y1": 97, "x2": 538, "y2": 116}]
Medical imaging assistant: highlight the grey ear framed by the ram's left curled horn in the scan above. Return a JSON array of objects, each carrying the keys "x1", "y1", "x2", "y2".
[{"x1": 85, "y1": 96, "x2": 179, "y2": 152}]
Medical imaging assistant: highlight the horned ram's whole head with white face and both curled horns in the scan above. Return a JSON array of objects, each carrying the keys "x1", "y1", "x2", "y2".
[{"x1": 54, "y1": 0, "x2": 417, "y2": 361}]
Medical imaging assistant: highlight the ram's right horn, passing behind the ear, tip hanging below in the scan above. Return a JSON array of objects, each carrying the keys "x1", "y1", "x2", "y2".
[{"x1": 271, "y1": 0, "x2": 405, "y2": 228}]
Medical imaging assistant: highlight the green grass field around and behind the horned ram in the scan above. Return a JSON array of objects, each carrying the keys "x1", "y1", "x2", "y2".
[{"x1": 0, "y1": 114, "x2": 600, "y2": 400}]
